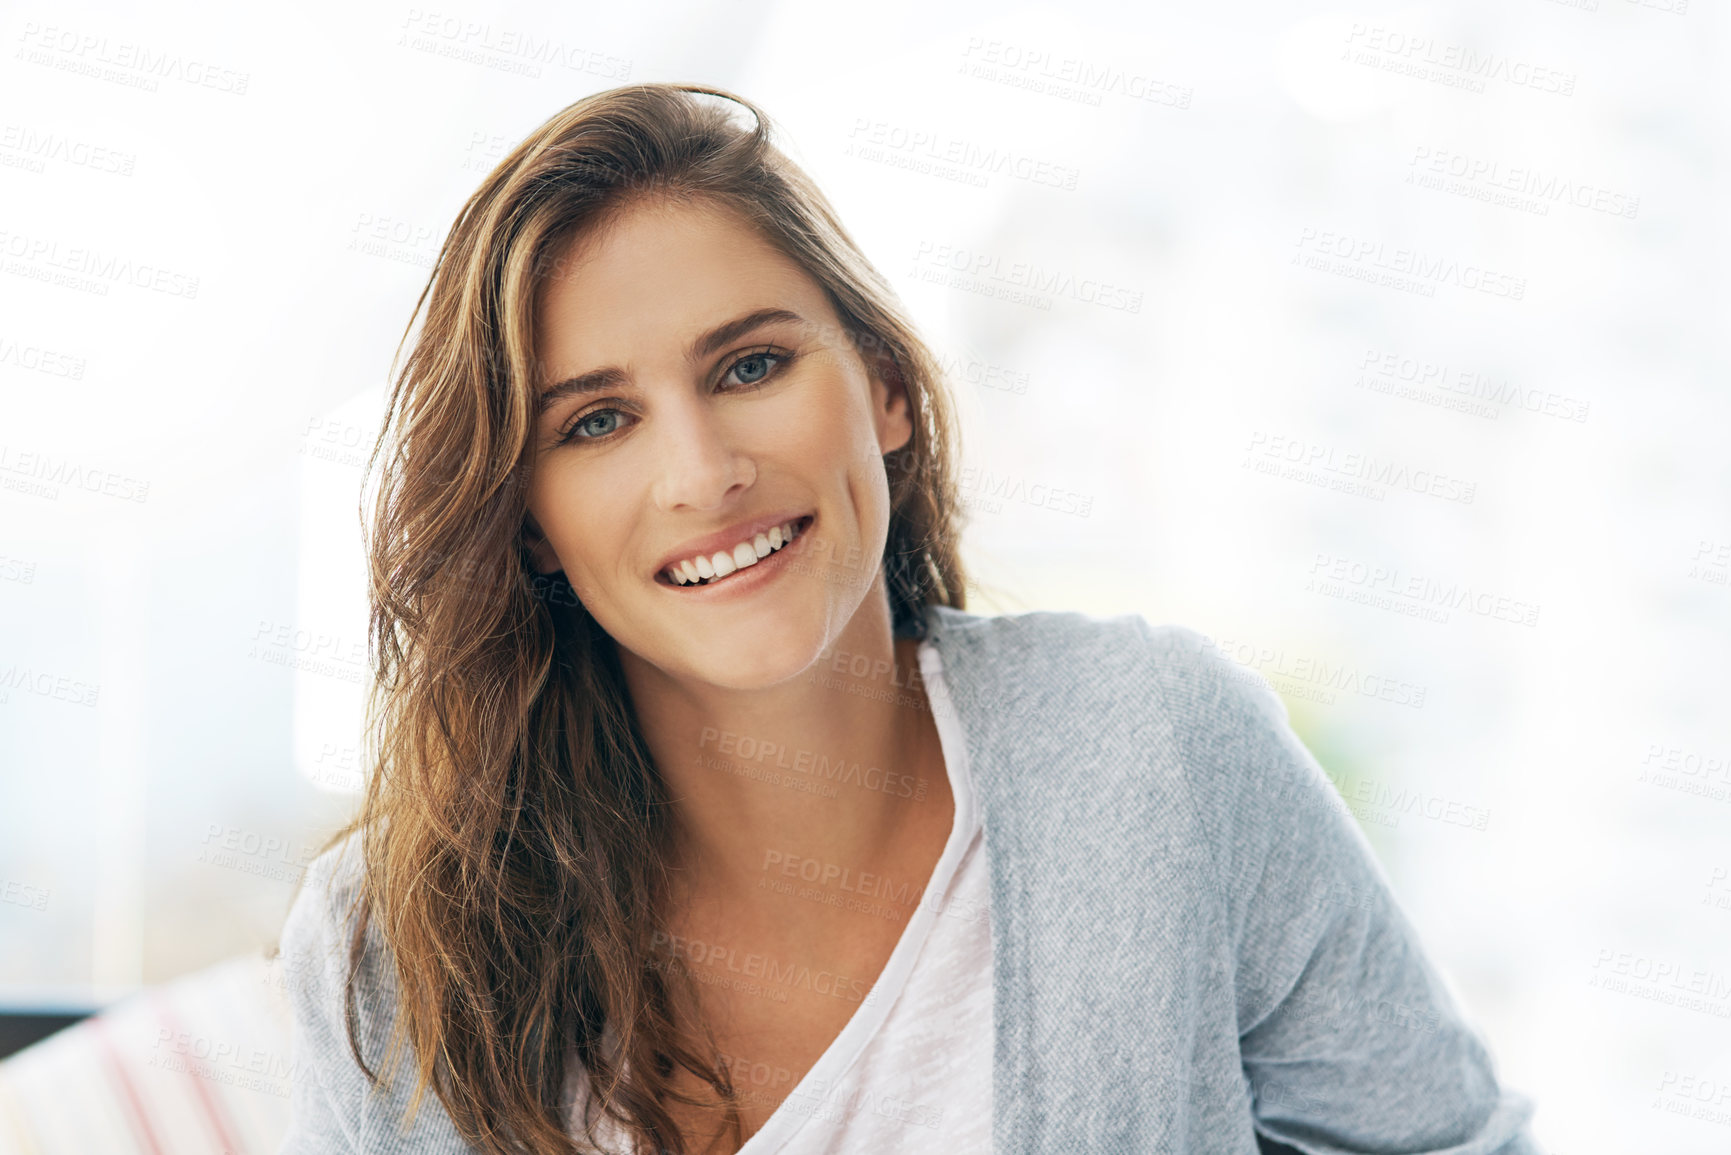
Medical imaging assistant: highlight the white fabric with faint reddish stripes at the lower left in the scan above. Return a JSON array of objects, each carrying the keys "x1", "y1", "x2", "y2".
[{"x1": 0, "y1": 956, "x2": 293, "y2": 1155}]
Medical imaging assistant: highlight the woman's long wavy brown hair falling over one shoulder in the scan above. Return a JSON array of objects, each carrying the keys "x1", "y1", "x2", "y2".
[{"x1": 313, "y1": 85, "x2": 966, "y2": 1155}]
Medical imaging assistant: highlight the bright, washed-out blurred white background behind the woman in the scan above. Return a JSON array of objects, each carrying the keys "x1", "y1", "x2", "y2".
[{"x1": 0, "y1": 0, "x2": 1731, "y2": 1155}]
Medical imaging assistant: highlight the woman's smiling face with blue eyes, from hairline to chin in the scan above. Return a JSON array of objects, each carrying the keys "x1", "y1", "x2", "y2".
[{"x1": 528, "y1": 199, "x2": 912, "y2": 689}]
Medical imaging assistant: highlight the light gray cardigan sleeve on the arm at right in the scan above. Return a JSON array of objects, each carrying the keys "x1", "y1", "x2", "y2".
[{"x1": 1151, "y1": 627, "x2": 1539, "y2": 1155}]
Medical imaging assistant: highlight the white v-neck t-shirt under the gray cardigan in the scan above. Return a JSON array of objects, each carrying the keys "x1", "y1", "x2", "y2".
[{"x1": 575, "y1": 641, "x2": 992, "y2": 1155}]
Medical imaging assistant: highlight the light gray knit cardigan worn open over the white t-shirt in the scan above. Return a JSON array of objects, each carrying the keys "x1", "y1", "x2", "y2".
[{"x1": 280, "y1": 606, "x2": 1539, "y2": 1155}]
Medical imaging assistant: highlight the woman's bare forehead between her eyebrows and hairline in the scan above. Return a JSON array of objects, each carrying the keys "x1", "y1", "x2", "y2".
[{"x1": 533, "y1": 197, "x2": 833, "y2": 376}]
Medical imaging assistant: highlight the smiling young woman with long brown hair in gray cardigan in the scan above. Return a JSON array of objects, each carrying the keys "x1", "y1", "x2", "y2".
[{"x1": 282, "y1": 85, "x2": 1535, "y2": 1155}]
